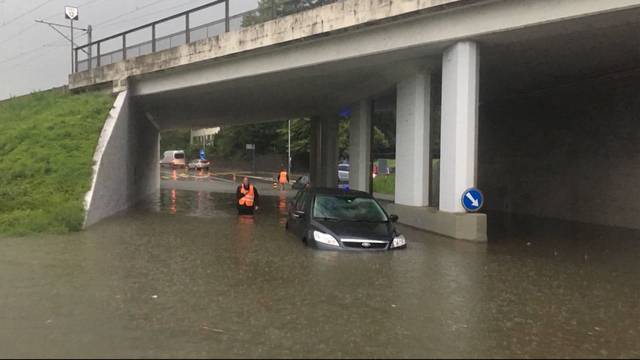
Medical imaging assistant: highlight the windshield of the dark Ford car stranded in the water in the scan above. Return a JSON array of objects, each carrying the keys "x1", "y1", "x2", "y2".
[{"x1": 313, "y1": 194, "x2": 388, "y2": 222}]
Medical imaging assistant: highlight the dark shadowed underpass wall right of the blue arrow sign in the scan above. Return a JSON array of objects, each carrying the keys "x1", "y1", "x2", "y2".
[{"x1": 478, "y1": 77, "x2": 640, "y2": 229}]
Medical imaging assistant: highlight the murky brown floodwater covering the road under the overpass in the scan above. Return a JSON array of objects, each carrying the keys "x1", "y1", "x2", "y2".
[{"x1": 0, "y1": 183, "x2": 640, "y2": 358}]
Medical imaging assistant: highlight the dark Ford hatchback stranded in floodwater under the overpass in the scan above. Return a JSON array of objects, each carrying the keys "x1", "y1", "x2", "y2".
[{"x1": 287, "y1": 188, "x2": 407, "y2": 250}]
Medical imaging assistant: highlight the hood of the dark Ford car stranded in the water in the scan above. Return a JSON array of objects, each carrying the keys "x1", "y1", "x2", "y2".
[{"x1": 313, "y1": 220, "x2": 394, "y2": 241}]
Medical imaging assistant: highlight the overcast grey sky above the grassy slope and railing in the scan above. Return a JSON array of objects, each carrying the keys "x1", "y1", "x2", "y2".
[{"x1": 0, "y1": 0, "x2": 258, "y2": 100}]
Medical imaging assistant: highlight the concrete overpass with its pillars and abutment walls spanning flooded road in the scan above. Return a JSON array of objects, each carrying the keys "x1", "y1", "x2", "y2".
[{"x1": 75, "y1": 0, "x2": 640, "y2": 240}]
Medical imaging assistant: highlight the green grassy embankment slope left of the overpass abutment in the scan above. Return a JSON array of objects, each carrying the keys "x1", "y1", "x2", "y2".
[{"x1": 0, "y1": 90, "x2": 113, "y2": 235}]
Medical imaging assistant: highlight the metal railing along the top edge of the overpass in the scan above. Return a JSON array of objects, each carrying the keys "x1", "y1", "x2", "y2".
[{"x1": 74, "y1": 0, "x2": 339, "y2": 72}]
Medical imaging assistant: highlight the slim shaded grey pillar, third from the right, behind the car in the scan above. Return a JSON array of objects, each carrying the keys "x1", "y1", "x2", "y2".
[{"x1": 349, "y1": 100, "x2": 371, "y2": 192}]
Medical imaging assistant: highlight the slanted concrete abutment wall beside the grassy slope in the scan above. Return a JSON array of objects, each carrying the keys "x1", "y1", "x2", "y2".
[{"x1": 84, "y1": 91, "x2": 160, "y2": 227}]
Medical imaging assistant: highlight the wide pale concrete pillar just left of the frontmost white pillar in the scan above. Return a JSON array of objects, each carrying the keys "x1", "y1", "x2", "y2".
[{"x1": 395, "y1": 72, "x2": 431, "y2": 206}]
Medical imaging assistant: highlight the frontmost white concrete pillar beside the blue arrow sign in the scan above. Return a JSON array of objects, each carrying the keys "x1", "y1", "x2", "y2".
[{"x1": 440, "y1": 41, "x2": 479, "y2": 212}]
